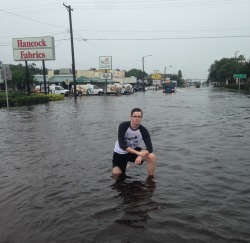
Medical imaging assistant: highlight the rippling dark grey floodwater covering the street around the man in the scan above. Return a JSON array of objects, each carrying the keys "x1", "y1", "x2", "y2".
[{"x1": 0, "y1": 88, "x2": 250, "y2": 243}]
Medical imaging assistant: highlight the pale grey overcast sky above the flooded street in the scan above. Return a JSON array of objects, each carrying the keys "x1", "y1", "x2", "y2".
[{"x1": 0, "y1": 0, "x2": 250, "y2": 79}]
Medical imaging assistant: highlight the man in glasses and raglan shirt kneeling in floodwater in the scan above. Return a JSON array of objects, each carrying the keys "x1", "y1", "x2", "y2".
[{"x1": 112, "y1": 108, "x2": 156, "y2": 178}]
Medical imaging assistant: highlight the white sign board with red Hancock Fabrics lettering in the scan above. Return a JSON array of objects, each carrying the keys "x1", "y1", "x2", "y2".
[{"x1": 12, "y1": 36, "x2": 55, "y2": 61}]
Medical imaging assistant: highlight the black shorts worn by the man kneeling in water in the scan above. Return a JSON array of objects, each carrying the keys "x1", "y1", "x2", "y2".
[{"x1": 113, "y1": 147, "x2": 143, "y2": 174}]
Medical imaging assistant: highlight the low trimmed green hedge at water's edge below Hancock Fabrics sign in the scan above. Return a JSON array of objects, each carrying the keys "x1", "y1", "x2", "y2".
[{"x1": 0, "y1": 92, "x2": 64, "y2": 108}]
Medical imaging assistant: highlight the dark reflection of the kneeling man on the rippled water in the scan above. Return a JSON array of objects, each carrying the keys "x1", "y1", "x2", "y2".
[{"x1": 111, "y1": 178, "x2": 157, "y2": 228}]
